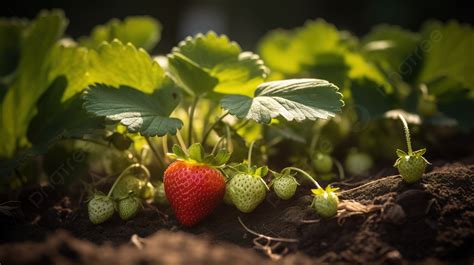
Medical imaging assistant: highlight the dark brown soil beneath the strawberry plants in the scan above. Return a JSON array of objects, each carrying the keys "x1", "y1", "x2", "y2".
[{"x1": 0, "y1": 163, "x2": 474, "y2": 265}]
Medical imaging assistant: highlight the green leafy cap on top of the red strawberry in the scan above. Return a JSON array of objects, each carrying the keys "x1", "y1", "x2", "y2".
[{"x1": 167, "y1": 143, "x2": 230, "y2": 168}]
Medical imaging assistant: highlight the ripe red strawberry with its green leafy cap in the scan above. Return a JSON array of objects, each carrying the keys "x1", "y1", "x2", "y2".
[{"x1": 163, "y1": 144, "x2": 229, "y2": 226}]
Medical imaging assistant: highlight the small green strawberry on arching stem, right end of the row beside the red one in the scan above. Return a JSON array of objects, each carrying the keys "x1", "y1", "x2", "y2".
[{"x1": 311, "y1": 186, "x2": 339, "y2": 218}]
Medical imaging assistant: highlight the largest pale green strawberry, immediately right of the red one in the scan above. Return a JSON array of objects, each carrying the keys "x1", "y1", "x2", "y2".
[{"x1": 227, "y1": 173, "x2": 267, "y2": 213}]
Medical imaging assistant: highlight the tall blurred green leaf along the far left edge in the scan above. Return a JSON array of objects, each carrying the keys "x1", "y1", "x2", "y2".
[{"x1": 0, "y1": 10, "x2": 67, "y2": 157}]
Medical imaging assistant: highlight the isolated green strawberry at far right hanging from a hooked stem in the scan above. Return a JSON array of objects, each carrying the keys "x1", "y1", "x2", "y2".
[{"x1": 394, "y1": 149, "x2": 429, "y2": 183}]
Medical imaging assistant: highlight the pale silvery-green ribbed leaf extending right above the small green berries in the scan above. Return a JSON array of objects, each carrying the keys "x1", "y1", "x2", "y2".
[{"x1": 221, "y1": 79, "x2": 344, "y2": 124}]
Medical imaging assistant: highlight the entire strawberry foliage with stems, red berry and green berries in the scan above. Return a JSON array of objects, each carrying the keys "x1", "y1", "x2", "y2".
[{"x1": 0, "y1": 10, "x2": 472, "y2": 226}]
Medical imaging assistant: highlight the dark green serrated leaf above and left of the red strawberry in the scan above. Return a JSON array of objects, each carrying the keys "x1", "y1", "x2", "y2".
[{"x1": 84, "y1": 80, "x2": 183, "y2": 136}]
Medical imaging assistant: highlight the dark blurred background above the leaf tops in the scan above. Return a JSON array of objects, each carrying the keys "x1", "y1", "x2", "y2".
[{"x1": 0, "y1": 0, "x2": 474, "y2": 53}]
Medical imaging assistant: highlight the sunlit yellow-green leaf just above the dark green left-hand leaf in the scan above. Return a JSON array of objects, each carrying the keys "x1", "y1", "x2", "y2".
[{"x1": 88, "y1": 40, "x2": 165, "y2": 93}]
